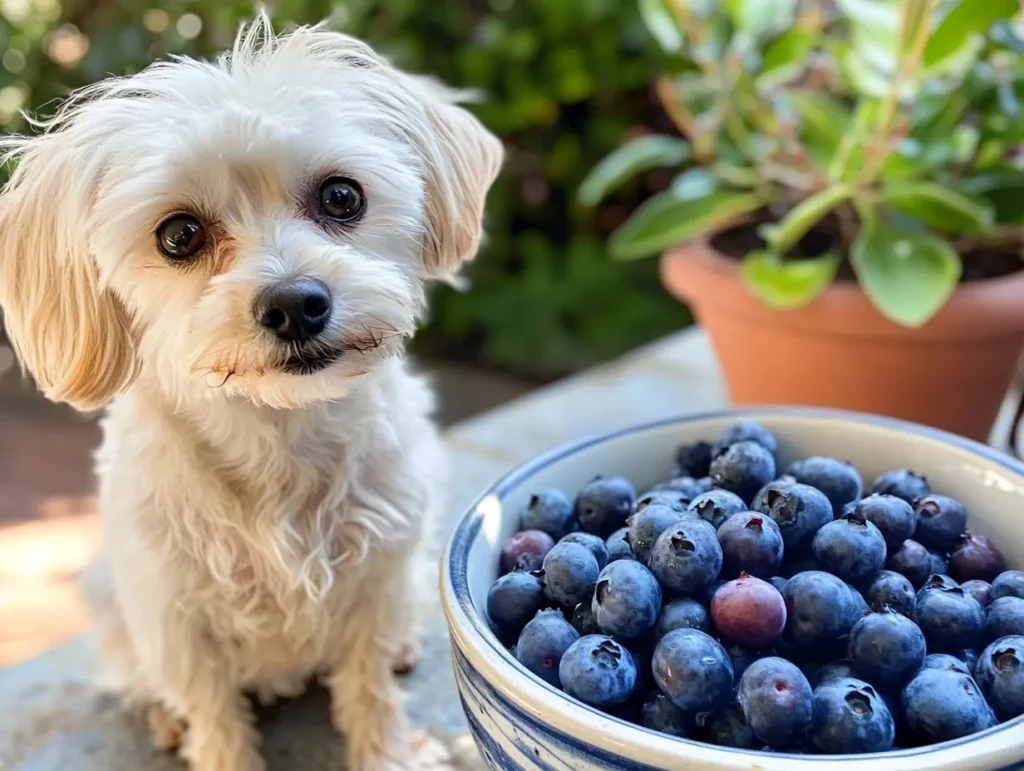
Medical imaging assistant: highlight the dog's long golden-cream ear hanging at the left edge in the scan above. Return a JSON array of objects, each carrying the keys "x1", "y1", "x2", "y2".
[{"x1": 0, "y1": 125, "x2": 136, "y2": 410}]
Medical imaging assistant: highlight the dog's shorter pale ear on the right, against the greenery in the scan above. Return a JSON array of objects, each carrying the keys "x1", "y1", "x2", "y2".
[{"x1": 399, "y1": 76, "x2": 504, "y2": 277}]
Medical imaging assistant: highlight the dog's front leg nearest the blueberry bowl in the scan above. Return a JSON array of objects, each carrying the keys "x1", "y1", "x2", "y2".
[{"x1": 327, "y1": 556, "x2": 414, "y2": 771}]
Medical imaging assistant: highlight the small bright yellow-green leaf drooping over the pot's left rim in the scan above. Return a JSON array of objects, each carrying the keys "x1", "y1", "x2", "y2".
[{"x1": 742, "y1": 251, "x2": 840, "y2": 310}]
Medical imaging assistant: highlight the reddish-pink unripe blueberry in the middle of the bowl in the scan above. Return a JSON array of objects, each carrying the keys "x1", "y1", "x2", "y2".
[{"x1": 711, "y1": 573, "x2": 785, "y2": 648}]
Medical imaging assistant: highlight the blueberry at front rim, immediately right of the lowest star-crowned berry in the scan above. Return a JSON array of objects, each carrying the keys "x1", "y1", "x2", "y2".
[{"x1": 902, "y1": 669, "x2": 996, "y2": 744}]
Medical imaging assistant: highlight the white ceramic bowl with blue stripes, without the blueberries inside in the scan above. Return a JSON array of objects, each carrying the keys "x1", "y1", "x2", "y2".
[{"x1": 441, "y1": 408, "x2": 1024, "y2": 771}]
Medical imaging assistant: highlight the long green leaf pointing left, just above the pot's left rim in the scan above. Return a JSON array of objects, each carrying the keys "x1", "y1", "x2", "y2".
[{"x1": 608, "y1": 189, "x2": 763, "y2": 260}]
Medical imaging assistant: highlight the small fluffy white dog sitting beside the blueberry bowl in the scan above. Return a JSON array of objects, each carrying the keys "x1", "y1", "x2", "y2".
[{"x1": 0, "y1": 13, "x2": 502, "y2": 771}]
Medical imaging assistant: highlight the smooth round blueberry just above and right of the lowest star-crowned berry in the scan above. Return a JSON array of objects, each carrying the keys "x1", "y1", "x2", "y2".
[{"x1": 847, "y1": 611, "x2": 927, "y2": 688}]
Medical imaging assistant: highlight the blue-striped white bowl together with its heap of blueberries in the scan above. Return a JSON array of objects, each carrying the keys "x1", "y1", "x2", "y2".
[{"x1": 441, "y1": 408, "x2": 1024, "y2": 771}]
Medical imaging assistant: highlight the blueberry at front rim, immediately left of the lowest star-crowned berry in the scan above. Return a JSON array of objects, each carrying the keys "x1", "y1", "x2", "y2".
[{"x1": 737, "y1": 656, "x2": 814, "y2": 746}]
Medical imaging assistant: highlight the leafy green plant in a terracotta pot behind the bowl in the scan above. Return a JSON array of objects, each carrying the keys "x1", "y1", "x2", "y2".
[{"x1": 580, "y1": 0, "x2": 1024, "y2": 439}]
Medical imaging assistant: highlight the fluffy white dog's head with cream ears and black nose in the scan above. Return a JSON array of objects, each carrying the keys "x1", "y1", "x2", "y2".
[{"x1": 0, "y1": 18, "x2": 502, "y2": 409}]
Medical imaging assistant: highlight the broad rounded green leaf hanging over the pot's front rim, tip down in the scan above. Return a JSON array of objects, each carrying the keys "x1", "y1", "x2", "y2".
[{"x1": 850, "y1": 221, "x2": 963, "y2": 327}]
